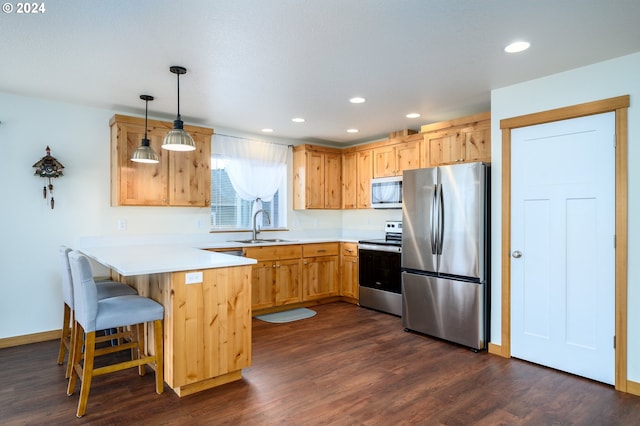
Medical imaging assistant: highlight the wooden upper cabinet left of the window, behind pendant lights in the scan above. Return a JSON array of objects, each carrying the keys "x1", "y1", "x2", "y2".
[{"x1": 109, "y1": 115, "x2": 213, "y2": 207}]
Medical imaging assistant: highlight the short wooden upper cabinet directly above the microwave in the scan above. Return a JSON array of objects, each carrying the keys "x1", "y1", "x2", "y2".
[{"x1": 373, "y1": 133, "x2": 423, "y2": 177}]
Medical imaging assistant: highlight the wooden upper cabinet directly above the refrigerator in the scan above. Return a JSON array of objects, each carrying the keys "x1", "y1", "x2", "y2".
[{"x1": 421, "y1": 113, "x2": 491, "y2": 167}]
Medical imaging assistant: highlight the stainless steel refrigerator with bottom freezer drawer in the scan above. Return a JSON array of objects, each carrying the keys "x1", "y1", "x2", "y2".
[{"x1": 401, "y1": 163, "x2": 489, "y2": 350}]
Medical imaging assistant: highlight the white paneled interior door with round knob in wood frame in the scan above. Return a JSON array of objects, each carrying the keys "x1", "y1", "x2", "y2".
[{"x1": 511, "y1": 112, "x2": 615, "y2": 384}]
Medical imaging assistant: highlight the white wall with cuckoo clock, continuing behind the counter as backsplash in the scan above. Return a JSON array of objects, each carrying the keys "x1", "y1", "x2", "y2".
[{"x1": 0, "y1": 93, "x2": 399, "y2": 339}]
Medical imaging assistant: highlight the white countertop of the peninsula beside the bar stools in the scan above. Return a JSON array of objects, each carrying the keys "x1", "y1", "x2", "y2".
[{"x1": 80, "y1": 244, "x2": 257, "y2": 276}]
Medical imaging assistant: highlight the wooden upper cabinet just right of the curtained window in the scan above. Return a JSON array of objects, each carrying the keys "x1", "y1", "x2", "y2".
[{"x1": 293, "y1": 145, "x2": 342, "y2": 209}]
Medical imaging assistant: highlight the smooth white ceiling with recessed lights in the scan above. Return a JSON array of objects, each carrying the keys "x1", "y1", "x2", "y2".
[{"x1": 0, "y1": 0, "x2": 640, "y2": 146}]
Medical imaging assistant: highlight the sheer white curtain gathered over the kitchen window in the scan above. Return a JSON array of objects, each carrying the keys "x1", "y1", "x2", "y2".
[{"x1": 212, "y1": 134, "x2": 288, "y2": 223}]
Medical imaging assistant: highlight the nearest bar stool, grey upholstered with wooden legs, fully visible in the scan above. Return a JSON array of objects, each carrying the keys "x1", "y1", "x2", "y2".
[{"x1": 67, "y1": 251, "x2": 164, "y2": 417}]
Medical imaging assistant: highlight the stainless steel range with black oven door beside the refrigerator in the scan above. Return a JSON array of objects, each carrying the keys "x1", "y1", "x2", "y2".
[{"x1": 358, "y1": 221, "x2": 402, "y2": 316}]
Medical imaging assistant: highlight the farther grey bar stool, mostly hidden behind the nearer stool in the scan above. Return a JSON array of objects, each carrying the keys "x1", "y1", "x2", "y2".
[{"x1": 58, "y1": 246, "x2": 138, "y2": 379}]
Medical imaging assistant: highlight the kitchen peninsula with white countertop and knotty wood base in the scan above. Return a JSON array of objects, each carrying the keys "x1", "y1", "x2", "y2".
[{"x1": 81, "y1": 245, "x2": 256, "y2": 396}]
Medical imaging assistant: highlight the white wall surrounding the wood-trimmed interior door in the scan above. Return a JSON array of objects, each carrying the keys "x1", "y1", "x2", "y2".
[{"x1": 491, "y1": 53, "x2": 640, "y2": 382}]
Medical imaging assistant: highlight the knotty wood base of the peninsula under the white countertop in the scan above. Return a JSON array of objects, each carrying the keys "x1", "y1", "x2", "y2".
[{"x1": 120, "y1": 265, "x2": 251, "y2": 397}]
